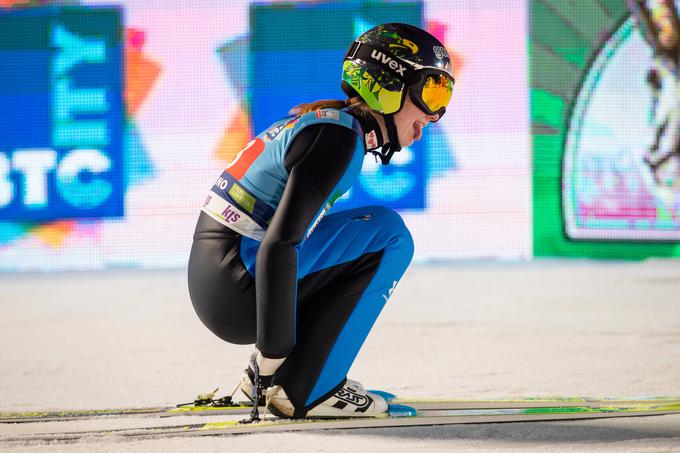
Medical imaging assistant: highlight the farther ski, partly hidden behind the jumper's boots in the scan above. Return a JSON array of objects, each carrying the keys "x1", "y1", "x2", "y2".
[{"x1": 0, "y1": 392, "x2": 680, "y2": 423}]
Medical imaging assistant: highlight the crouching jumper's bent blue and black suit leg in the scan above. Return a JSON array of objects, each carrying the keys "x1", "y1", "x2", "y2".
[{"x1": 273, "y1": 207, "x2": 413, "y2": 412}]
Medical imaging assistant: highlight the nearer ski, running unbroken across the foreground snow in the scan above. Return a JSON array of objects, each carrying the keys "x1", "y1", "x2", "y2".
[{"x1": 5, "y1": 401, "x2": 680, "y2": 443}]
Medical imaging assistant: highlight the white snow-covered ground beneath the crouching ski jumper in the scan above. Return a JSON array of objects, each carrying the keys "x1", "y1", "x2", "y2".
[{"x1": 0, "y1": 260, "x2": 680, "y2": 453}]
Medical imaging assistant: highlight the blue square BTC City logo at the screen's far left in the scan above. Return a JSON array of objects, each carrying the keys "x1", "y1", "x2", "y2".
[{"x1": 0, "y1": 7, "x2": 125, "y2": 221}]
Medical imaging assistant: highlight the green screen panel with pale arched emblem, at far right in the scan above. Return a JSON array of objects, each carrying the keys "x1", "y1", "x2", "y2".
[{"x1": 531, "y1": 0, "x2": 680, "y2": 258}]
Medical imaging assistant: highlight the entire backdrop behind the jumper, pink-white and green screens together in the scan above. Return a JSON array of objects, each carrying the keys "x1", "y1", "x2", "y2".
[{"x1": 0, "y1": 0, "x2": 680, "y2": 272}]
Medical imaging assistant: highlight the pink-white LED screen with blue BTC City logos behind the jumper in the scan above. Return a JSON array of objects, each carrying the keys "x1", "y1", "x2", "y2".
[{"x1": 0, "y1": 0, "x2": 531, "y2": 271}]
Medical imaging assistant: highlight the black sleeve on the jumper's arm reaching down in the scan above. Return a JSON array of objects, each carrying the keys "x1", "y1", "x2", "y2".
[{"x1": 255, "y1": 123, "x2": 357, "y2": 358}]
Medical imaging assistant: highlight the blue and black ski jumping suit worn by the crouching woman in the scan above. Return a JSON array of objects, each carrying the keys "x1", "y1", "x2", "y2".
[{"x1": 188, "y1": 109, "x2": 413, "y2": 416}]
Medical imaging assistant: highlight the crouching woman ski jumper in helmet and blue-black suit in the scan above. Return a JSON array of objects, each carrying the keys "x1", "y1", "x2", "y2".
[{"x1": 188, "y1": 23, "x2": 454, "y2": 418}]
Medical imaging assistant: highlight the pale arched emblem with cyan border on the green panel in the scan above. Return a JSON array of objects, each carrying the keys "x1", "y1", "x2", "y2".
[{"x1": 563, "y1": 10, "x2": 680, "y2": 241}]
